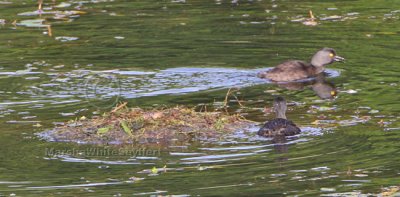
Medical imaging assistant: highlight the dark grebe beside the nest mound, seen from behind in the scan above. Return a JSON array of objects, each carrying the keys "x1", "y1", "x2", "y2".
[{"x1": 257, "y1": 96, "x2": 301, "y2": 137}]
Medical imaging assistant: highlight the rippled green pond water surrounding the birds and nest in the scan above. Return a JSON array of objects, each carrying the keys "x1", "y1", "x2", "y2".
[{"x1": 0, "y1": 0, "x2": 400, "y2": 196}]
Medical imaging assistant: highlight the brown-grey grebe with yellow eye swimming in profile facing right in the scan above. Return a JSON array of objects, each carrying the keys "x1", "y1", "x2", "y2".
[{"x1": 257, "y1": 48, "x2": 344, "y2": 82}]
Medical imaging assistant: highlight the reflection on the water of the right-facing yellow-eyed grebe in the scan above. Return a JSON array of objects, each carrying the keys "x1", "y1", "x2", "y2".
[{"x1": 277, "y1": 73, "x2": 338, "y2": 99}]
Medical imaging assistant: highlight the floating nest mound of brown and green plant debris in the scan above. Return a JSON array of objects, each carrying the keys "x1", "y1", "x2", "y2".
[{"x1": 42, "y1": 103, "x2": 252, "y2": 144}]
